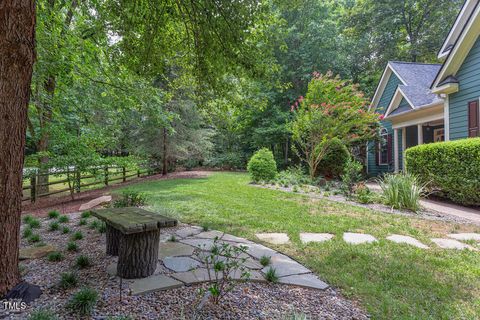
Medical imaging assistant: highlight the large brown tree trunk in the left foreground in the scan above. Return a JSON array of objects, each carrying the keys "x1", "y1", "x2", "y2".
[{"x1": 0, "y1": 0, "x2": 35, "y2": 297}]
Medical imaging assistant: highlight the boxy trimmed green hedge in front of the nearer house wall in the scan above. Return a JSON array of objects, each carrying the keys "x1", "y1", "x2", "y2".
[{"x1": 405, "y1": 138, "x2": 480, "y2": 205}]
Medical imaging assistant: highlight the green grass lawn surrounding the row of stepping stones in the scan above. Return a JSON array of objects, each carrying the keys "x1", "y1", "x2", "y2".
[{"x1": 117, "y1": 173, "x2": 480, "y2": 319}]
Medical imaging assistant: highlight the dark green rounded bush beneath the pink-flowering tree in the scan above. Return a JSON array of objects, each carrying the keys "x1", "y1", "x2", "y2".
[{"x1": 317, "y1": 138, "x2": 350, "y2": 178}]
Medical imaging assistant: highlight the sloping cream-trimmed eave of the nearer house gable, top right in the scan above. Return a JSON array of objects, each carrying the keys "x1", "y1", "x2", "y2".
[{"x1": 431, "y1": 0, "x2": 480, "y2": 93}]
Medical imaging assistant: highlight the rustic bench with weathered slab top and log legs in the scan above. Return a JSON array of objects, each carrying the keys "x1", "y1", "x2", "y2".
[{"x1": 92, "y1": 207, "x2": 177, "y2": 279}]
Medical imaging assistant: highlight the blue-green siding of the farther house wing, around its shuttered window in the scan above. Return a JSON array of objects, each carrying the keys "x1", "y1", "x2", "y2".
[{"x1": 367, "y1": 73, "x2": 406, "y2": 176}]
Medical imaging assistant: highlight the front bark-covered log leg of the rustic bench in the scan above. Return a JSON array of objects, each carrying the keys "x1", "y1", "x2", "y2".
[{"x1": 117, "y1": 230, "x2": 160, "y2": 279}]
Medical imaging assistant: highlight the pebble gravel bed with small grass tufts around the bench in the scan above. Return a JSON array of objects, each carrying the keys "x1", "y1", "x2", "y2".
[{"x1": 0, "y1": 214, "x2": 368, "y2": 319}]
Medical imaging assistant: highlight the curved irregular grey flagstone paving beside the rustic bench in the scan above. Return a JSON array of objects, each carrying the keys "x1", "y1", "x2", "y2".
[{"x1": 107, "y1": 226, "x2": 328, "y2": 295}]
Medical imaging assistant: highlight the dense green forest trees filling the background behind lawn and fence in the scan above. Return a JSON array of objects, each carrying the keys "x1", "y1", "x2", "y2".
[{"x1": 26, "y1": 0, "x2": 463, "y2": 170}]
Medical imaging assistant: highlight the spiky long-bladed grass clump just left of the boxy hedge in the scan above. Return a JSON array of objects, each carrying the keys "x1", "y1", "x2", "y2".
[{"x1": 379, "y1": 173, "x2": 426, "y2": 212}]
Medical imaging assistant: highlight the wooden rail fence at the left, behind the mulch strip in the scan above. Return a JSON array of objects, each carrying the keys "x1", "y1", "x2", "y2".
[{"x1": 22, "y1": 166, "x2": 160, "y2": 202}]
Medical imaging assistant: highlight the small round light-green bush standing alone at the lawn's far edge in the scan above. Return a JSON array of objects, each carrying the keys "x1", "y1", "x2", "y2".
[{"x1": 247, "y1": 148, "x2": 277, "y2": 182}]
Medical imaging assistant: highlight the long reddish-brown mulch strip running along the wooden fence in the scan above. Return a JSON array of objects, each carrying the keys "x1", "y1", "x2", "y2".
[{"x1": 22, "y1": 171, "x2": 210, "y2": 217}]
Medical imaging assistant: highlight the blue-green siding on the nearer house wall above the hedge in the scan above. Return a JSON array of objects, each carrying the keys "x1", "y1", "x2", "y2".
[{"x1": 449, "y1": 38, "x2": 480, "y2": 140}]
